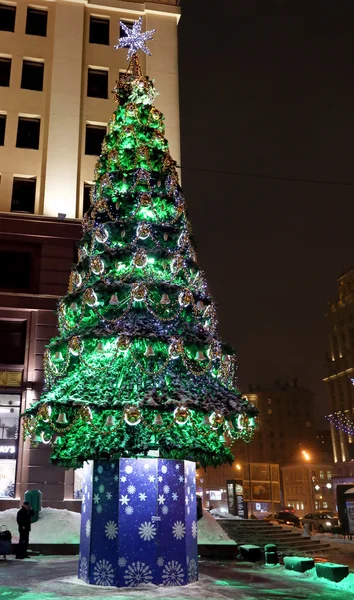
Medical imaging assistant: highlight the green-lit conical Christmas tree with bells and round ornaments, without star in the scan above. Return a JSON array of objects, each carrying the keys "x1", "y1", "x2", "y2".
[{"x1": 24, "y1": 22, "x2": 257, "y2": 468}]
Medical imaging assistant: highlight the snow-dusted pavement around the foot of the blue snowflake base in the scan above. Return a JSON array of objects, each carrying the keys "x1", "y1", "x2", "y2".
[{"x1": 0, "y1": 557, "x2": 353, "y2": 600}]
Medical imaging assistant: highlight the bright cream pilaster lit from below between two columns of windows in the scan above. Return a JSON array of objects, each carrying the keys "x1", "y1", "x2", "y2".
[{"x1": 43, "y1": 1, "x2": 84, "y2": 218}]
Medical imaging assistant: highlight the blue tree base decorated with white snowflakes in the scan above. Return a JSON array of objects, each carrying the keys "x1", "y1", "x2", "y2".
[{"x1": 79, "y1": 458, "x2": 198, "y2": 587}]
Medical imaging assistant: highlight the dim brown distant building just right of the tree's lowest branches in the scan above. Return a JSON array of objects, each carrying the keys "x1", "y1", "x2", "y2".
[{"x1": 234, "y1": 379, "x2": 318, "y2": 464}]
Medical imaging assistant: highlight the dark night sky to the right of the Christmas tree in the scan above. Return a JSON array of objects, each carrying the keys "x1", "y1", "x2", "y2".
[{"x1": 179, "y1": 0, "x2": 354, "y2": 422}]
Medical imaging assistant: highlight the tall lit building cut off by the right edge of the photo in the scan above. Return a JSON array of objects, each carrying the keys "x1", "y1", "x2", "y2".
[{"x1": 324, "y1": 269, "x2": 354, "y2": 464}]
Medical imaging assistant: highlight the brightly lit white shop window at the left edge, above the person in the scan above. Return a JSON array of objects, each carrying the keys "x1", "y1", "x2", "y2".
[{"x1": 0, "y1": 394, "x2": 21, "y2": 498}]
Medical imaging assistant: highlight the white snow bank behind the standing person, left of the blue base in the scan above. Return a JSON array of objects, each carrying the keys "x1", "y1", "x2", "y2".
[{"x1": 0, "y1": 508, "x2": 81, "y2": 544}]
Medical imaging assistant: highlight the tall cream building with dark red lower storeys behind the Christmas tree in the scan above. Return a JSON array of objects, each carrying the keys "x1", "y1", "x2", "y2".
[{"x1": 0, "y1": 0, "x2": 180, "y2": 509}]
